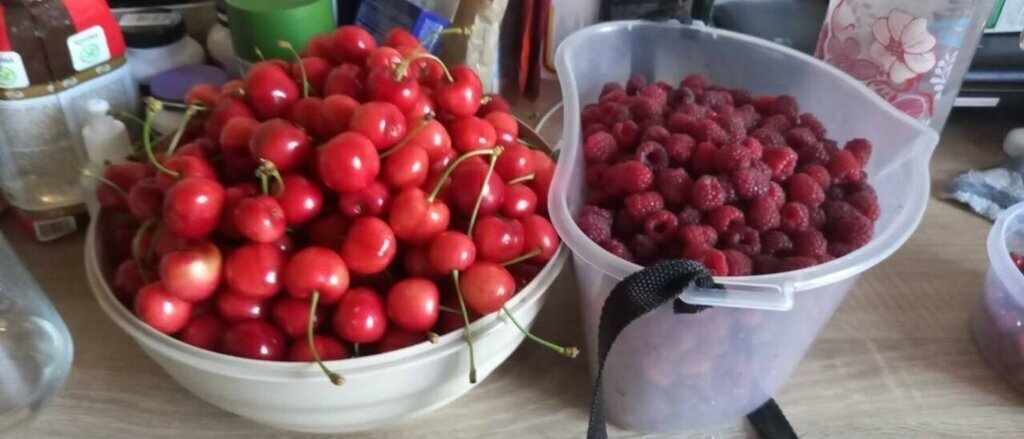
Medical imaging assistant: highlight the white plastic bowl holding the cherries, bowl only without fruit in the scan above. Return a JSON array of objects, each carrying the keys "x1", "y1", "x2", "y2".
[{"x1": 85, "y1": 221, "x2": 567, "y2": 433}]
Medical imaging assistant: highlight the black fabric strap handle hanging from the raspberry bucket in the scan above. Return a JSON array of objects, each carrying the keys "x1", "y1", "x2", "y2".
[{"x1": 587, "y1": 260, "x2": 797, "y2": 439}]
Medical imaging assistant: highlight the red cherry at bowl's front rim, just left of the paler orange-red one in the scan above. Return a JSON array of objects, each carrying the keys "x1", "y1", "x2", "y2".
[{"x1": 333, "y1": 288, "x2": 387, "y2": 343}]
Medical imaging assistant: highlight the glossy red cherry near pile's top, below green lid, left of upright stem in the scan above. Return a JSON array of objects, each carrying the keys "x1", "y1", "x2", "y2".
[{"x1": 245, "y1": 63, "x2": 302, "y2": 120}]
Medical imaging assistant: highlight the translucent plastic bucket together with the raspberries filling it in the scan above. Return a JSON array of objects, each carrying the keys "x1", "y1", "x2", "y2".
[{"x1": 549, "y1": 21, "x2": 938, "y2": 432}]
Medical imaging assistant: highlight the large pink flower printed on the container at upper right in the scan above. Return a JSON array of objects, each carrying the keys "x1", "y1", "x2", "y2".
[{"x1": 868, "y1": 9, "x2": 937, "y2": 84}]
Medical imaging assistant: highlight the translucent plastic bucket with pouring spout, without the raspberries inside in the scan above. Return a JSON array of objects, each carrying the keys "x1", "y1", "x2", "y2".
[{"x1": 549, "y1": 21, "x2": 938, "y2": 432}]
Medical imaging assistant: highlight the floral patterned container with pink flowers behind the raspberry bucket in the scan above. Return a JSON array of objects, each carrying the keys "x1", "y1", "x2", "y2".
[{"x1": 816, "y1": 0, "x2": 994, "y2": 131}]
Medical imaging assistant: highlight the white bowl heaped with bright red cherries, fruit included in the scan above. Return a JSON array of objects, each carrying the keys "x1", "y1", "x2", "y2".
[{"x1": 86, "y1": 26, "x2": 578, "y2": 432}]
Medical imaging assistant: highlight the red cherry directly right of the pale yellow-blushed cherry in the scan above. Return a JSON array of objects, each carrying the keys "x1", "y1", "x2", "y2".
[{"x1": 224, "y1": 244, "x2": 285, "y2": 299}]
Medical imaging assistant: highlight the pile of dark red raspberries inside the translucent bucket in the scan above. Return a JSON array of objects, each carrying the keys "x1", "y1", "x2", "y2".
[{"x1": 578, "y1": 75, "x2": 880, "y2": 276}]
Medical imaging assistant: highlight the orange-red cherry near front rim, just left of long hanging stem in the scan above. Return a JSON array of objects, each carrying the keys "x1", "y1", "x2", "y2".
[{"x1": 387, "y1": 277, "x2": 440, "y2": 332}]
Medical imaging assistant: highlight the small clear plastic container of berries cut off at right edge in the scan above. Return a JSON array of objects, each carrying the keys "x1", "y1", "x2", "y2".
[{"x1": 971, "y1": 203, "x2": 1024, "y2": 390}]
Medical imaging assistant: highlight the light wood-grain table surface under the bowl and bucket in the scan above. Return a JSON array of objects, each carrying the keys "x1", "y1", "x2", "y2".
[{"x1": 0, "y1": 105, "x2": 1024, "y2": 433}]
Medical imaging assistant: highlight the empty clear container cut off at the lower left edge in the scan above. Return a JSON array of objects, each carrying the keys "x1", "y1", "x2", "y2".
[{"x1": 0, "y1": 233, "x2": 73, "y2": 433}]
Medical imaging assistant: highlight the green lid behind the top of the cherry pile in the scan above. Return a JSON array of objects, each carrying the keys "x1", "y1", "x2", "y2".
[{"x1": 227, "y1": 0, "x2": 337, "y2": 62}]
